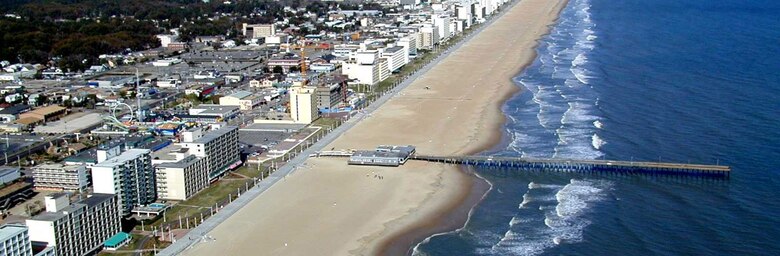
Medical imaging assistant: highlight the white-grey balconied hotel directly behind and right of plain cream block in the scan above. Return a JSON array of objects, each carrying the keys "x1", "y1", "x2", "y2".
[{"x1": 181, "y1": 126, "x2": 241, "y2": 181}]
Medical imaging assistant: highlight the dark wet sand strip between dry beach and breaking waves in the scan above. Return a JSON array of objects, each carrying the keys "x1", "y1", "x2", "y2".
[{"x1": 380, "y1": 0, "x2": 569, "y2": 255}]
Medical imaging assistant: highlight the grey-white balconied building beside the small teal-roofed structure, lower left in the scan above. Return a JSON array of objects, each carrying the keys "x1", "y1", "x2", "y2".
[{"x1": 25, "y1": 194, "x2": 121, "y2": 256}]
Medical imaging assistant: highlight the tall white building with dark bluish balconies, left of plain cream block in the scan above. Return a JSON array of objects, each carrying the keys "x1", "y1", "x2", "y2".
[{"x1": 90, "y1": 149, "x2": 157, "y2": 215}]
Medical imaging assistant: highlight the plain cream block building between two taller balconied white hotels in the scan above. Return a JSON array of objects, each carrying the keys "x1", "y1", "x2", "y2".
[{"x1": 155, "y1": 155, "x2": 209, "y2": 200}]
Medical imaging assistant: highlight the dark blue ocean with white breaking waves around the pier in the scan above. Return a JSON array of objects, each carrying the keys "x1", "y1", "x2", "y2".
[{"x1": 415, "y1": 0, "x2": 780, "y2": 255}]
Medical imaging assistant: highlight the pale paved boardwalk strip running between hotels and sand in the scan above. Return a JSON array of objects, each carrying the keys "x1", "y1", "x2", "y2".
[{"x1": 158, "y1": 1, "x2": 517, "y2": 255}]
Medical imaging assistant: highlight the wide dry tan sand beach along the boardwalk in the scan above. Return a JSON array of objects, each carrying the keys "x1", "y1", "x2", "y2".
[{"x1": 184, "y1": 0, "x2": 566, "y2": 255}]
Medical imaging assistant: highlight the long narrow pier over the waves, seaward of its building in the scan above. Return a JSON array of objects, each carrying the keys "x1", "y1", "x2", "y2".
[{"x1": 410, "y1": 155, "x2": 731, "y2": 178}]
